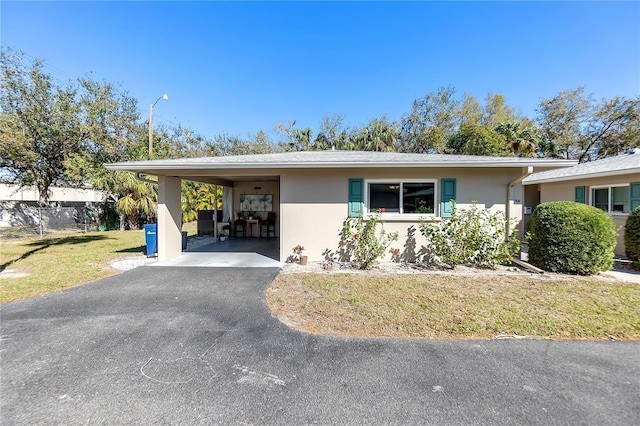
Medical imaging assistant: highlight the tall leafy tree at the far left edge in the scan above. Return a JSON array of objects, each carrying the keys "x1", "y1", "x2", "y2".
[{"x1": 0, "y1": 52, "x2": 81, "y2": 206}]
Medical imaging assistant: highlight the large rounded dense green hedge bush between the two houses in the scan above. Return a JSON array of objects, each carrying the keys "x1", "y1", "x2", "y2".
[{"x1": 527, "y1": 201, "x2": 617, "y2": 275}]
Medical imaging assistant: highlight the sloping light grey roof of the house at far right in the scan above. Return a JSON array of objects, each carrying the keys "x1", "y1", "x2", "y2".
[{"x1": 522, "y1": 148, "x2": 640, "y2": 185}]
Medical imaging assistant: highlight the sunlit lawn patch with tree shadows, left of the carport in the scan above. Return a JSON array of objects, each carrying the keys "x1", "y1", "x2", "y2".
[{"x1": 0, "y1": 228, "x2": 145, "y2": 302}]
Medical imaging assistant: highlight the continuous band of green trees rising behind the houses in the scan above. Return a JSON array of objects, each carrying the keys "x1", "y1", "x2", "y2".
[{"x1": 0, "y1": 49, "x2": 640, "y2": 226}]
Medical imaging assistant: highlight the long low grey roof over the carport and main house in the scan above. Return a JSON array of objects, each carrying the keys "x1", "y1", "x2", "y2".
[{"x1": 106, "y1": 150, "x2": 576, "y2": 175}]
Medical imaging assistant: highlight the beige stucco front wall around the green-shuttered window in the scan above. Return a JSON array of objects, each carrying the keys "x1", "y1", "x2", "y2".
[{"x1": 280, "y1": 168, "x2": 522, "y2": 261}]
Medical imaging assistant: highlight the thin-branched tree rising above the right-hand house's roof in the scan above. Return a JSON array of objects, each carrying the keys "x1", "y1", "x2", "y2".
[{"x1": 537, "y1": 87, "x2": 640, "y2": 162}]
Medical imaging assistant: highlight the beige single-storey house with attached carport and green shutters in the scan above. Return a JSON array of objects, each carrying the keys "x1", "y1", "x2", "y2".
[{"x1": 107, "y1": 150, "x2": 576, "y2": 261}]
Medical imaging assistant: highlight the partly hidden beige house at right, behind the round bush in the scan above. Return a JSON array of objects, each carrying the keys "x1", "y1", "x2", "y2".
[{"x1": 522, "y1": 148, "x2": 640, "y2": 256}]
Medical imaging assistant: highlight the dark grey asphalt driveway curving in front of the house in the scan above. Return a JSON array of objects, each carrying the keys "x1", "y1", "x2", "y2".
[{"x1": 0, "y1": 266, "x2": 640, "y2": 425}]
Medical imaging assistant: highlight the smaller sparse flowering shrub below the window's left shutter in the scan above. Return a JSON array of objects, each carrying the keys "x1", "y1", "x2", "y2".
[{"x1": 341, "y1": 214, "x2": 398, "y2": 269}]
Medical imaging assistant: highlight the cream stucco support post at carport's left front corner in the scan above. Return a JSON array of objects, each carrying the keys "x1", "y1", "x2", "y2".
[{"x1": 157, "y1": 176, "x2": 182, "y2": 261}]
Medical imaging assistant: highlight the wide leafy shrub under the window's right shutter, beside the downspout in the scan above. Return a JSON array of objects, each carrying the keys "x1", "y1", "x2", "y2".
[{"x1": 420, "y1": 202, "x2": 520, "y2": 269}]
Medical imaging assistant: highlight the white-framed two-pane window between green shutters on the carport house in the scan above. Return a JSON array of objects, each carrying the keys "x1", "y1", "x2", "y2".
[{"x1": 367, "y1": 181, "x2": 435, "y2": 215}]
